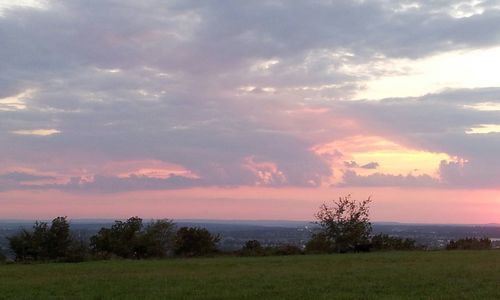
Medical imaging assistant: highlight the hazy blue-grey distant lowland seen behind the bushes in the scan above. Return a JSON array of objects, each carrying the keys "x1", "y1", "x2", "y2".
[{"x1": 0, "y1": 220, "x2": 500, "y2": 257}]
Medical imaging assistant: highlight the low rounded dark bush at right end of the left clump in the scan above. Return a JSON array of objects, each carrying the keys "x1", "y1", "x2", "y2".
[{"x1": 175, "y1": 227, "x2": 220, "y2": 256}]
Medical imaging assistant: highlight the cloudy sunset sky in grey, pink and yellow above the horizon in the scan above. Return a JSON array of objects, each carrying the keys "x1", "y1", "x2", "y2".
[{"x1": 0, "y1": 0, "x2": 500, "y2": 224}]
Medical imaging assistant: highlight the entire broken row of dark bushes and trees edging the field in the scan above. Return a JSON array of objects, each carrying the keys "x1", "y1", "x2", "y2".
[{"x1": 0, "y1": 195, "x2": 492, "y2": 262}]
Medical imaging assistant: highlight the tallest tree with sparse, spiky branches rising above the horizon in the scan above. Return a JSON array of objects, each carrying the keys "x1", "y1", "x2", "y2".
[{"x1": 316, "y1": 195, "x2": 372, "y2": 253}]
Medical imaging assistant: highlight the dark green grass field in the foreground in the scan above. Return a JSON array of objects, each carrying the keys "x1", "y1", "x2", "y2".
[{"x1": 0, "y1": 251, "x2": 500, "y2": 299}]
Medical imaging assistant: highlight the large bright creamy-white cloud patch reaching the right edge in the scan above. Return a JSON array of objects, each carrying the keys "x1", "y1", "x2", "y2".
[{"x1": 355, "y1": 47, "x2": 500, "y2": 99}]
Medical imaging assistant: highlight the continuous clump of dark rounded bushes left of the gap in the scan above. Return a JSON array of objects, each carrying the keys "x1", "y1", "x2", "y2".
[{"x1": 8, "y1": 217, "x2": 220, "y2": 262}]
